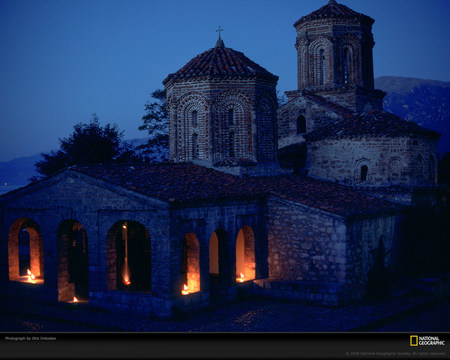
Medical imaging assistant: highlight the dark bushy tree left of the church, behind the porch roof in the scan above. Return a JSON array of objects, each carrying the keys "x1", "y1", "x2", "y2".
[{"x1": 30, "y1": 114, "x2": 138, "y2": 181}]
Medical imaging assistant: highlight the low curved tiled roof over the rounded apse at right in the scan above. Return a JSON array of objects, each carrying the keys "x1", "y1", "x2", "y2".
[{"x1": 304, "y1": 111, "x2": 440, "y2": 141}]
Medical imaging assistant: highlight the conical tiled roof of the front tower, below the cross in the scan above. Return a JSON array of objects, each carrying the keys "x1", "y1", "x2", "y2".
[{"x1": 163, "y1": 39, "x2": 278, "y2": 84}]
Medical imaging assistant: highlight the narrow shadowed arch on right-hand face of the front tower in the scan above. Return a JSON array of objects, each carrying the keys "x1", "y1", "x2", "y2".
[{"x1": 256, "y1": 95, "x2": 277, "y2": 161}]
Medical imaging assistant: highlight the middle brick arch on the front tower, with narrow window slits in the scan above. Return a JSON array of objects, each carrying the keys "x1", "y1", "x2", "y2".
[{"x1": 213, "y1": 89, "x2": 253, "y2": 161}]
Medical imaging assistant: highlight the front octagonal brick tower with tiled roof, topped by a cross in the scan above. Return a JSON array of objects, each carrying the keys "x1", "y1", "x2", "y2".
[{"x1": 163, "y1": 36, "x2": 278, "y2": 175}]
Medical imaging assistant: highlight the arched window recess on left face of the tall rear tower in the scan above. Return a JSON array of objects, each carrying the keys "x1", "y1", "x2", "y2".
[{"x1": 309, "y1": 37, "x2": 333, "y2": 86}]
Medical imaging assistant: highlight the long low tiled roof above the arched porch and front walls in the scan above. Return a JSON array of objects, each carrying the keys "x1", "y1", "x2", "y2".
[{"x1": 70, "y1": 163, "x2": 401, "y2": 217}]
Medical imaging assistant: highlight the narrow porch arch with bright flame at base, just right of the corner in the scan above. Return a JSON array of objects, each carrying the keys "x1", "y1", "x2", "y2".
[{"x1": 181, "y1": 233, "x2": 201, "y2": 294}]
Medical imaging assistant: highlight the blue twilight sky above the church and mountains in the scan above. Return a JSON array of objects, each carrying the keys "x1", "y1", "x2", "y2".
[{"x1": 0, "y1": 0, "x2": 450, "y2": 161}]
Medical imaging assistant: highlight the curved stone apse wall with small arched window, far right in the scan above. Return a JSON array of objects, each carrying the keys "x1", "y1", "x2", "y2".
[{"x1": 307, "y1": 136, "x2": 437, "y2": 186}]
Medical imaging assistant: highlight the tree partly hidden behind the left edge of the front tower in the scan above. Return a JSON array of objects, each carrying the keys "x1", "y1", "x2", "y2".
[{"x1": 137, "y1": 89, "x2": 169, "y2": 162}]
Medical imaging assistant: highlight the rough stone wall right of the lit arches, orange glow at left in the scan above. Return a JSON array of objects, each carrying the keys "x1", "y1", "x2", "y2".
[{"x1": 267, "y1": 198, "x2": 346, "y2": 283}]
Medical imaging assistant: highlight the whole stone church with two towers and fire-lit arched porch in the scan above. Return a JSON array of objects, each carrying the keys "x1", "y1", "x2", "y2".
[{"x1": 0, "y1": 0, "x2": 439, "y2": 316}]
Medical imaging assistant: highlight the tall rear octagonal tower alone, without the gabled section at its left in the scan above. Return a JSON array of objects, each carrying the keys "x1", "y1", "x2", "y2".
[{"x1": 294, "y1": 0, "x2": 384, "y2": 111}]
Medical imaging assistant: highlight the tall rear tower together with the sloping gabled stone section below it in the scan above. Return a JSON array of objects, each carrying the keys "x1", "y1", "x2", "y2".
[{"x1": 278, "y1": 0, "x2": 385, "y2": 148}]
